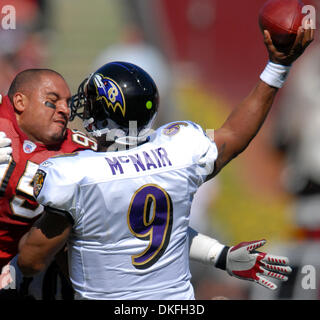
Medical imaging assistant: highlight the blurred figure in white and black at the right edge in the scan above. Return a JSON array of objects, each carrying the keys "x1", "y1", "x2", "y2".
[{"x1": 250, "y1": 44, "x2": 320, "y2": 300}]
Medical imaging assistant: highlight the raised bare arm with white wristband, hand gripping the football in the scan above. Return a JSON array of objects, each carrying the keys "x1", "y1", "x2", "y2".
[{"x1": 210, "y1": 28, "x2": 314, "y2": 178}]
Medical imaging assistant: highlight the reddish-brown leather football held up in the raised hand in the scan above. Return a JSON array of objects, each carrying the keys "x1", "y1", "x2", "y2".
[{"x1": 259, "y1": 0, "x2": 304, "y2": 51}]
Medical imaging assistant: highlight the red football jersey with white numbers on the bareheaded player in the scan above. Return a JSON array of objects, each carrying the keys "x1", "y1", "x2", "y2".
[{"x1": 0, "y1": 96, "x2": 97, "y2": 271}]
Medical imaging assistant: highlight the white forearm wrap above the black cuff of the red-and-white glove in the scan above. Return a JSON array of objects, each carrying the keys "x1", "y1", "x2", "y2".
[{"x1": 189, "y1": 233, "x2": 225, "y2": 265}]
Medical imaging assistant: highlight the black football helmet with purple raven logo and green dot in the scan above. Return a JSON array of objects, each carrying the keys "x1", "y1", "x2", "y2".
[{"x1": 70, "y1": 62, "x2": 159, "y2": 144}]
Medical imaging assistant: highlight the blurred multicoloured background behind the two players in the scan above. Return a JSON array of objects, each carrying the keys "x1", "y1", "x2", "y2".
[{"x1": 0, "y1": 0, "x2": 320, "y2": 299}]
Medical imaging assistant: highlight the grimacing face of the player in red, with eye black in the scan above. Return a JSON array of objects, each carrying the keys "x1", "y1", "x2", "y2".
[{"x1": 19, "y1": 74, "x2": 71, "y2": 145}]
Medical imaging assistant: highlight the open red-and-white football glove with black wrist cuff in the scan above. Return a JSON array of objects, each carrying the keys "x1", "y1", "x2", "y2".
[{"x1": 216, "y1": 240, "x2": 292, "y2": 290}]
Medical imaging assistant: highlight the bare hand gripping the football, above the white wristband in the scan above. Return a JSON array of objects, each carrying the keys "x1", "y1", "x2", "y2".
[{"x1": 264, "y1": 27, "x2": 315, "y2": 66}]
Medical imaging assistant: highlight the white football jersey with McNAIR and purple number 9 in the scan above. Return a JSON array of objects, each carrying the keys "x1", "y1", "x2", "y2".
[{"x1": 35, "y1": 121, "x2": 217, "y2": 300}]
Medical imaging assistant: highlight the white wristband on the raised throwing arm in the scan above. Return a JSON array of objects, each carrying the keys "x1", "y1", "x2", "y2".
[{"x1": 260, "y1": 61, "x2": 291, "y2": 88}]
